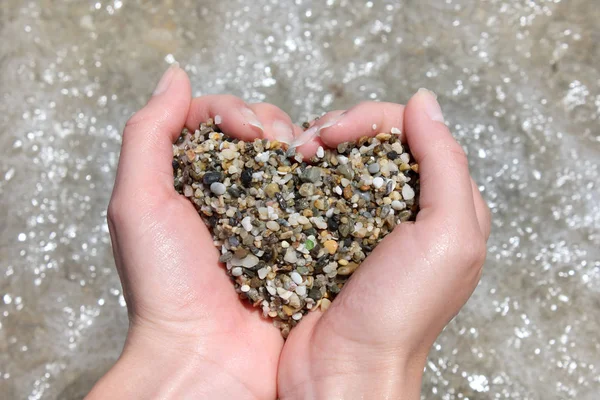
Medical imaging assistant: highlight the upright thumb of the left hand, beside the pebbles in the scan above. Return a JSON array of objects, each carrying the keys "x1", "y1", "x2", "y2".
[{"x1": 115, "y1": 65, "x2": 191, "y2": 200}]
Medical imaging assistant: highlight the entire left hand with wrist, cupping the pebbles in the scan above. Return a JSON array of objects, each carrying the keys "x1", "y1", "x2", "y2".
[{"x1": 89, "y1": 67, "x2": 300, "y2": 399}]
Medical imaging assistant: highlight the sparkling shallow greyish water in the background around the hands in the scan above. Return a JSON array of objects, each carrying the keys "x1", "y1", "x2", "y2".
[{"x1": 0, "y1": 0, "x2": 600, "y2": 399}]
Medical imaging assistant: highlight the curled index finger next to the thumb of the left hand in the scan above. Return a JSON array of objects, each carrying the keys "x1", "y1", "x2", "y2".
[{"x1": 185, "y1": 94, "x2": 264, "y2": 141}]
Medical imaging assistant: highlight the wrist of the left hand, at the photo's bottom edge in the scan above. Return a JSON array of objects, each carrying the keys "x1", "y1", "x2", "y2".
[{"x1": 87, "y1": 326, "x2": 257, "y2": 400}]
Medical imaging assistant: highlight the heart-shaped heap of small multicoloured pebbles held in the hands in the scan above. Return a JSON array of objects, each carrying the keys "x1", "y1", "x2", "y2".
[{"x1": 173, "y1": 121, "x2": 419, "y2": 337}]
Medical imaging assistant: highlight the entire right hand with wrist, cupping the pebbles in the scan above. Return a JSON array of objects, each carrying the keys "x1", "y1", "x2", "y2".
[{"x1": 278, "y1": 90, "x2": 490, "y2": 400}]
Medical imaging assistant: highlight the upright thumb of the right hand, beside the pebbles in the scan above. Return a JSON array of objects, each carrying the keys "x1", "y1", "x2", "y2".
[{"x1": 404, "y1": 89, "x2": 476, "y2": 223}]
